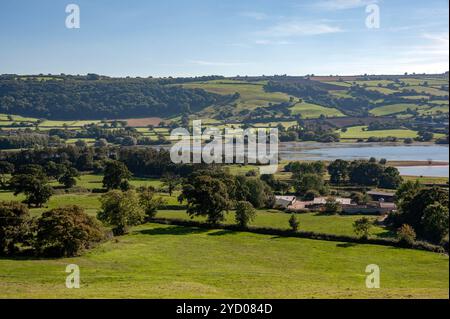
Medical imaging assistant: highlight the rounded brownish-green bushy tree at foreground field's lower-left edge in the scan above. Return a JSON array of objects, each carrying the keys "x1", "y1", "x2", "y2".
[{"x1": 34, "y1": 206, "x2": 104, "y2": 257}]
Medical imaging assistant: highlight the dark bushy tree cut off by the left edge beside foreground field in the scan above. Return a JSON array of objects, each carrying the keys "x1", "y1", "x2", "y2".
[{"x1": 0, "y1": 202, "x2": 31, "y2": 255}]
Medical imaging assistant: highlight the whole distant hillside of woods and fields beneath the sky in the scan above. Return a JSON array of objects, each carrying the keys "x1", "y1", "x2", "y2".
[{"x1": 0, "y1": 74, "x2": 449, "y2": 123}]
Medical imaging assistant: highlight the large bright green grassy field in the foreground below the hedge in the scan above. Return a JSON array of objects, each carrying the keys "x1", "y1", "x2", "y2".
[{"x1": 0, "y1": 224, "x2": 449, "y2": 298}]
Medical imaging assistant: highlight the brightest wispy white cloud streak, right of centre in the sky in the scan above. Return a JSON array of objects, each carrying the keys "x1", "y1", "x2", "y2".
[{"x1": 257, "y1": 21, "x2": 343, "y2": 38}]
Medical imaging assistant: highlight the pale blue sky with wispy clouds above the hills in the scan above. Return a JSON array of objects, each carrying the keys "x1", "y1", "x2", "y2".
[{"x1": 0, "y1": 0, "x2": 449, "y2": 76}]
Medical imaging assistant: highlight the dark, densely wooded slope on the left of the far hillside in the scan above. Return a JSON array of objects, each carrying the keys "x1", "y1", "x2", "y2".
[{"x1": 0, "y1": 75, "x2": 233, "y2": 120}]
